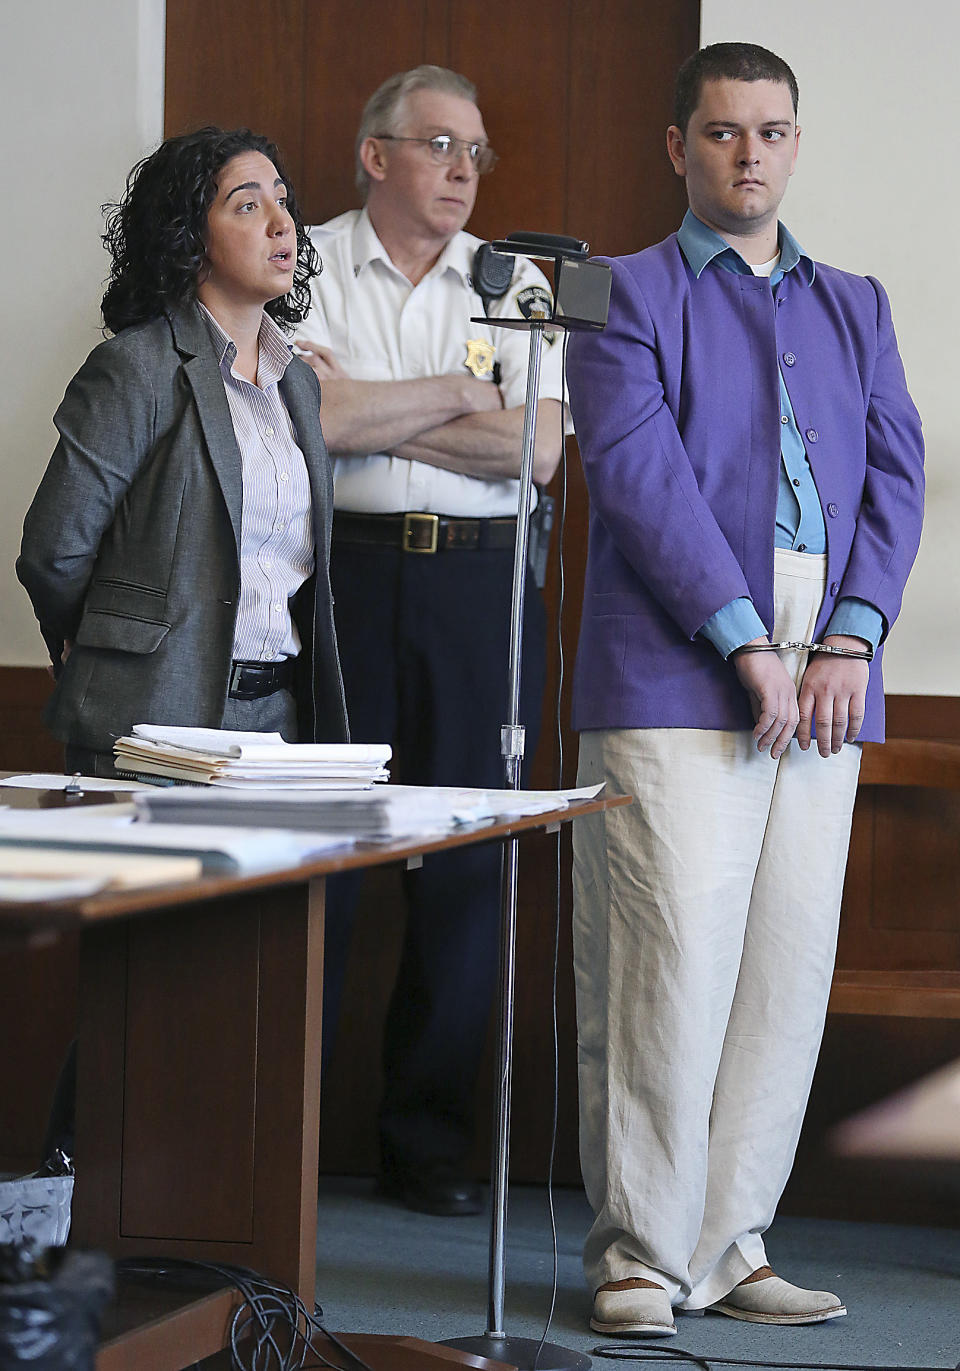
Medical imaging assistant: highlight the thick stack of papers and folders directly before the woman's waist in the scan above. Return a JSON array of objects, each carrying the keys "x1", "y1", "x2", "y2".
[{"x1": 114, "y1": 724, "x2": 391, "y2": 790}]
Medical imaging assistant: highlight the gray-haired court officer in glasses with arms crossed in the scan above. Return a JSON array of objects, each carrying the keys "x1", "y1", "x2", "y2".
[{"x1": 298, "y1": 66, "x2": 562, "y2": 1215}]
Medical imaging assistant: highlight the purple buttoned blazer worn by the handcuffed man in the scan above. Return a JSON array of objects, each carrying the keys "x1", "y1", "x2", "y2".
[{"x1": 568, "y1": 233, "x2": 923, "y2": 742}]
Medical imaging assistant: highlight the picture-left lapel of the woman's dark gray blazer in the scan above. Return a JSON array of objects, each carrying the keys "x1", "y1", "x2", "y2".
[{"x1": 169, "y1": 306, "x2": 243, "y2": 557}]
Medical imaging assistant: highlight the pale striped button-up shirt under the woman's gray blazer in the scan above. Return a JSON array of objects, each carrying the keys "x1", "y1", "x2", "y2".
[{"x1": 200, "y1": 304, "x2": 314, "y2": 662}]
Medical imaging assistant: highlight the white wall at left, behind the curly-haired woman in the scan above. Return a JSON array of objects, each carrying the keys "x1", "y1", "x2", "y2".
[{"x1": 0, "y1": 0, "x2": 165, "y2": 666}]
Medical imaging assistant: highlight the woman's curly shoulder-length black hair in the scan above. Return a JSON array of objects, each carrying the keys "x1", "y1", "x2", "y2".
[{"x1": 100, "y1": 126, "x2": 321, "y2": 333}]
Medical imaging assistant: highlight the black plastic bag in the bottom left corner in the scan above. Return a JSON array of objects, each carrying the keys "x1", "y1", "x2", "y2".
[{"x1": 0, "y1": 1245, "x2": 114, "y2": 1371}]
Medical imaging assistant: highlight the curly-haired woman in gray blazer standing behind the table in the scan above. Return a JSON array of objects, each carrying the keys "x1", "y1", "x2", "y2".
[{"x1": 16, "y1": 128, "x2": 347, "y2": 776}]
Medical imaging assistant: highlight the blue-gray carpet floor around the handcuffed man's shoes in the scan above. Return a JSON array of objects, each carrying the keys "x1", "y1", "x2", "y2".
[{"x1": 317, "y1": 1176, "x2": 960, "y2": 1371}]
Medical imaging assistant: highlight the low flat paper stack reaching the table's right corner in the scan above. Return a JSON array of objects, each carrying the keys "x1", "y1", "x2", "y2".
[{"x1": 134, "y1": 786, "x2": 601, "y2": 842}]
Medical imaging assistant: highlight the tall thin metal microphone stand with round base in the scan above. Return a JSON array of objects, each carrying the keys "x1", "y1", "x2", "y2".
[{"x1": 444, "y1": 240, "x2": 591, "y2": 1371}]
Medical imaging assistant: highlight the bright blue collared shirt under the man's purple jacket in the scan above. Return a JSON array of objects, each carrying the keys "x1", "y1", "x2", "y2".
[{"x1": 677, "y1": 210, "x2": 885, "y2": 657}]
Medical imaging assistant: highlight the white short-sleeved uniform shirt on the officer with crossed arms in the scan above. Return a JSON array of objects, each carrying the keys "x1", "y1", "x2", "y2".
[{"x1": 299, "y1": 210, "x2": 562, "y2": 518}]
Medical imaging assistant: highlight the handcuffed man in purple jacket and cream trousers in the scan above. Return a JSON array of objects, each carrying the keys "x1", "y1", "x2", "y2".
[{"x1": 569, "y1": 43, "x2": 923, "y2": 1335}]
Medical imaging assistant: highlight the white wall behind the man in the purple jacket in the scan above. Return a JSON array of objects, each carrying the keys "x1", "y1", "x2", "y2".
[{"x1": 701, "y1": 0, "x2": 960, "y2": 695}]
